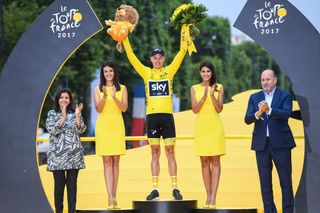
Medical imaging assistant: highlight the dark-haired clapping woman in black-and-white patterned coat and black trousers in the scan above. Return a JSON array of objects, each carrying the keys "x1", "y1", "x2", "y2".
[{"x1": 46, "y1": 90, "x2": 86, "y2": 213}]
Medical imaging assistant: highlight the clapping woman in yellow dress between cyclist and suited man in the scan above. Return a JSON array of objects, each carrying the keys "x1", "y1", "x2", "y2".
[{"x1": 190, "y1": 61, "x2": 226, "y2": 208}]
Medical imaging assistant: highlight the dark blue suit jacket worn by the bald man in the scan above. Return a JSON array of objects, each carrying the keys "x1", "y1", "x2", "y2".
[{"x1": 245, "y1": 88, "x2": 296, "y2": 151}]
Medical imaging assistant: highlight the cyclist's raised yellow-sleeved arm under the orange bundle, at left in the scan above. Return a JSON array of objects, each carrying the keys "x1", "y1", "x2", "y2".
[{"x1": 123, "y1": 36, "x2": 148, "y2": 78}]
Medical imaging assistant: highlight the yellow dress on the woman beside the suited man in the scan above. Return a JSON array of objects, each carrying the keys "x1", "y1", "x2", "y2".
[{"x1": 193, "y1": 84, "x2": 226, "y2": 156}]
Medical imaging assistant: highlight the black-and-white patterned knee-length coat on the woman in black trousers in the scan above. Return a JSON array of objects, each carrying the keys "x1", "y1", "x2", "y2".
[{"x1": 46, "y1": 110, "x2": 87, "y2": 171}]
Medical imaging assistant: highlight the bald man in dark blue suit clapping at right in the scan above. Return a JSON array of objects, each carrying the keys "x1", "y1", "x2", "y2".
[{"x1": 245, "y1": 70, "x2": 296, "y2": 213}]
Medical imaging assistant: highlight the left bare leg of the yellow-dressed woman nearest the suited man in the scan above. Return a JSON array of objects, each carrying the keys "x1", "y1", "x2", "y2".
[{"x1": 200, "y1": 156, "x2": 212, "y2": 205}]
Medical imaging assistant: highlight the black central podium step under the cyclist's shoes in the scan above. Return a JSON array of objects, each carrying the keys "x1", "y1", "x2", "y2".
[{"x1": 132, "y1": 200, "x2": 197, "y2": 213}]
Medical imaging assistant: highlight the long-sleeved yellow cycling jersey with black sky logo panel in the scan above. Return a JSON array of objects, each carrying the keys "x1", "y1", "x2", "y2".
[{"x1": 123, "y1": 37, "x2": 187, "y2": 115}]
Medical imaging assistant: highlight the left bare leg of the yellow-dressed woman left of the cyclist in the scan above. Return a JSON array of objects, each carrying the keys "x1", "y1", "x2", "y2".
[{"x1": 102, "y1": 156, "x2": 114, "y2": 206}]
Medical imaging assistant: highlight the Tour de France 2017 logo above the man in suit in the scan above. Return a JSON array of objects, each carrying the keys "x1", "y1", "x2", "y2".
[{"x1": 253, "y1": 1, "x2": 287, "y2": 35}]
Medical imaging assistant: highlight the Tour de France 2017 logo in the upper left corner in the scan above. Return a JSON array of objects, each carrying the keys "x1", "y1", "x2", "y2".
[{"x1": 50, "y1": 6, "x2": 82, "y2": 39}]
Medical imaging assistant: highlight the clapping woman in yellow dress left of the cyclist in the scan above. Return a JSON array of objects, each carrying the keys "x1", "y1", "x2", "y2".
[{"x1": 94, "y1": 61, "x2": 128, "y2": 209}]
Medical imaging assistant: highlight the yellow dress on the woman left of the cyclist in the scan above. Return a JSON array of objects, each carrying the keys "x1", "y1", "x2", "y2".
[{"x1": 95, "y1": 85, "x2": 126, "y2": 156}]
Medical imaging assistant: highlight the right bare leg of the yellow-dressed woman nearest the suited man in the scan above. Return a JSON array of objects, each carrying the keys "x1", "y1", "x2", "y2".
[{"x1": 211, "y1": 156, "x2": 221, "y2": 205}]
